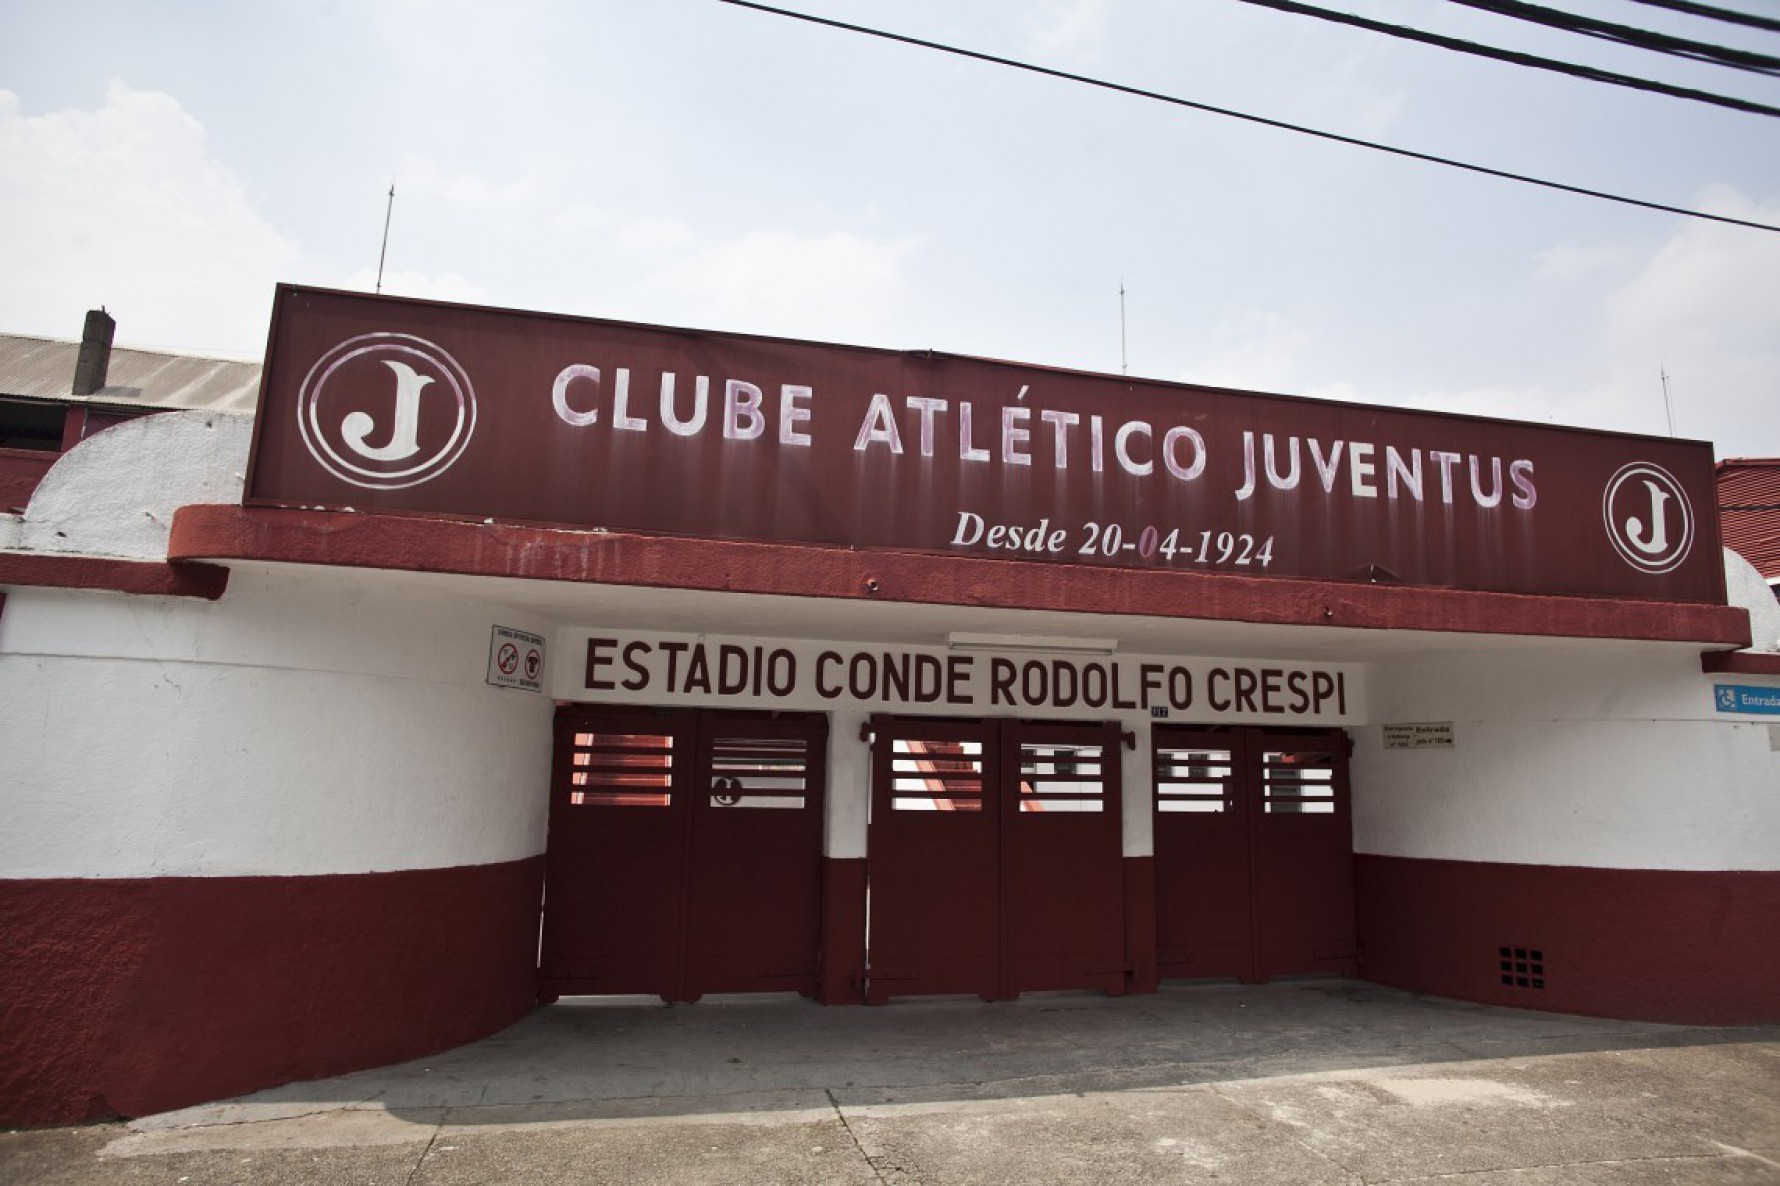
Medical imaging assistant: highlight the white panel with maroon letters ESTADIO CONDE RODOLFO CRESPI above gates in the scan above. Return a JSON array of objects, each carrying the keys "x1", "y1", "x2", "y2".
[{"x1": 555, "y1": 626, "x2": 1362, "y2": 725}]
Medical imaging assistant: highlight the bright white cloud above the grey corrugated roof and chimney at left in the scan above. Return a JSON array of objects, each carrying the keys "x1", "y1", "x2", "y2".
[{"x1": 0, "y1": 82, "x2": 299, "y2": 351}]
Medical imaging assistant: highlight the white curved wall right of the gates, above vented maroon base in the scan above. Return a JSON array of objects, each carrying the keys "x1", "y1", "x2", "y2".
[{"x1": 1351, "y1": 645, "x2": 1780, "y2": 869}]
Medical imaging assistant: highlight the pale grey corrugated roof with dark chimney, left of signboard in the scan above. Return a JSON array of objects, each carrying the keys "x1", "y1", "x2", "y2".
[{"x1": 0, "y1": 333, "x2": 260, "y2": 411}]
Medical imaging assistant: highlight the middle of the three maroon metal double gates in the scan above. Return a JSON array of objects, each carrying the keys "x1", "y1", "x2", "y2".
[{"x1": 867, "y1": 718, "x2": 1129, "y2": 1004}]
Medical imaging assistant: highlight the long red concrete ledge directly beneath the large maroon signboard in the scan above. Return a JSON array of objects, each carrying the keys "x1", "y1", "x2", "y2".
[{"x1": 167, "y1": 506, "x2": 1750, "y2": 646}]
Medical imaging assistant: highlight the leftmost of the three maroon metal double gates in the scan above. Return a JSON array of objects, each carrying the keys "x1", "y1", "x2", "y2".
[{"x1": 539, "y1": 705, "x2": 828, "y2": 1001}]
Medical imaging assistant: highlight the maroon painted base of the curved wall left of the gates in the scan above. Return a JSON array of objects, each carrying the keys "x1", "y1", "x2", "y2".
[{"x1": 0, "y1": 857, "x2": 543, "y2": 1125}]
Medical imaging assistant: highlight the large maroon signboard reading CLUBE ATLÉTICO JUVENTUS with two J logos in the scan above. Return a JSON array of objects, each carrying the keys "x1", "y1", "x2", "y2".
[{"x1": 247, "y1": 287, "x2": 1723, "y2": 602}]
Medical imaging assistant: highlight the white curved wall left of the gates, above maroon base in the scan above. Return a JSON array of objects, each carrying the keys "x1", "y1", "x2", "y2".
[{"x1": 0, "y1": 570, "x2": 554, "y2": 878}]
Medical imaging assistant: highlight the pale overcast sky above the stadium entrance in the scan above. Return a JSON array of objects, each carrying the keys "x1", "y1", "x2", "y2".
[{"x1": 0, "y1": 0, "x2": 1780, "y2": 456}]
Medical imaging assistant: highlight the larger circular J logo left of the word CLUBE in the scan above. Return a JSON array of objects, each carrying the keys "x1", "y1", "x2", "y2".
[{"x1": 297, "y1": 333, "x2": 475, "y2": 490}]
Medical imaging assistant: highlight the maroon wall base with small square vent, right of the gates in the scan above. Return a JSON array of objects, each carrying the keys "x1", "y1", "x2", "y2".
[{"x1": 1355, "y1": 855, "x2": 1780, "y2": 1026}]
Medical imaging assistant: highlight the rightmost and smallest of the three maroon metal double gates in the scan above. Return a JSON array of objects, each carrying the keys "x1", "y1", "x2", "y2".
[{"x1": 1153, "y1": 727, "x2": 1356, "y2": 981}]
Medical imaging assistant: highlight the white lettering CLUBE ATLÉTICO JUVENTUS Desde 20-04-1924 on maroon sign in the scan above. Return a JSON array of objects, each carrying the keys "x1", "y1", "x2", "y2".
[{"x1": 534, "y1": 363, "x2": 1566, "y2": 587}]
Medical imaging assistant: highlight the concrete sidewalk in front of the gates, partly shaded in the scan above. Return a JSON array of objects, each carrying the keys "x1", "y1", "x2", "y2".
[{"x1": 0, "y1": 981, "x2": 1780, "y2": 1186}]
